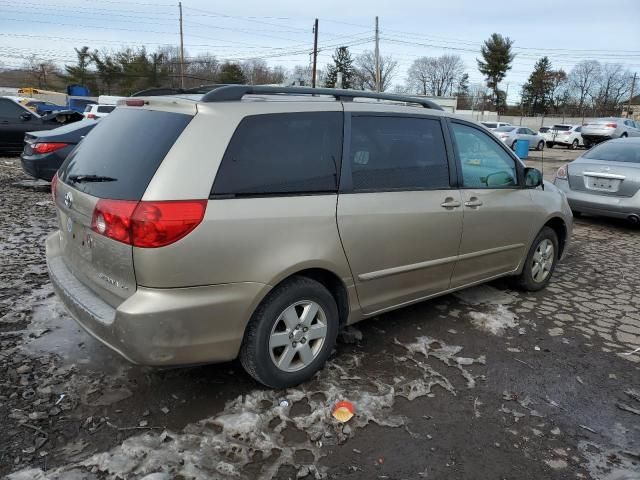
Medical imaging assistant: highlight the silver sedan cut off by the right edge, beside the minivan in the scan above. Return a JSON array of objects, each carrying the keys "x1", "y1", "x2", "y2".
[{"x1": 554, "y1": 138, "x2": 640, "y2": 224}]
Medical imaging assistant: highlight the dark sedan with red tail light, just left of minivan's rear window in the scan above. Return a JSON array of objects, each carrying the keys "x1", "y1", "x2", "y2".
[{"x1": 20, "y1": 120, "x2": 98, "y2": 182}]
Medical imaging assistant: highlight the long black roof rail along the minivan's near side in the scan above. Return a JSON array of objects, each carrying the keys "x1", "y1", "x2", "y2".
[{"x1": 201, "y1": 85, "x2": 442, "y2": 110}]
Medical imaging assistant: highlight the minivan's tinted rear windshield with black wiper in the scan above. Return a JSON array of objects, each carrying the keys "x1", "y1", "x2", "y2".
[{"x1": 58, "y1": 108, "x2": 193, "y2": 200}]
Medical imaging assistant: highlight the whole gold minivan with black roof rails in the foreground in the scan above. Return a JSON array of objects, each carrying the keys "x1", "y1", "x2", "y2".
[{"x1": 46, "y1": 85, "x2": 572, "y2": 387}]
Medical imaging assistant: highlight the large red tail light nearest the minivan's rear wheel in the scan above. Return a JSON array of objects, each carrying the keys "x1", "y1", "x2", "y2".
[{"x1": 91, "y1": 199, "x2": 207, "y2": 248}]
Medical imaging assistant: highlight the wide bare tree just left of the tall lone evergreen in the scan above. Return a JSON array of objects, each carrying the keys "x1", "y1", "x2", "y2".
[{"x1": 407, "y1": 55, "x2": 464, "y2": 97}]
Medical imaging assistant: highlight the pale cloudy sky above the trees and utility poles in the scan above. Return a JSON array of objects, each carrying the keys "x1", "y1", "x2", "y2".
[{"x1": 0, "y1": 0, "x2": 640, "y2": 101}]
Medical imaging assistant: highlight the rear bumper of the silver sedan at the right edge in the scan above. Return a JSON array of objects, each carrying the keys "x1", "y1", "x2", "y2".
[{"x1": 554, "y1": 179, "x2": 640, "y2": 218}]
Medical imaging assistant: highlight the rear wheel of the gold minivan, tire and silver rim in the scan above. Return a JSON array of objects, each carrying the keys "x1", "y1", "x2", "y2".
[{"x1": 240, "y1": 277, "x2": 339, "y2": 388}]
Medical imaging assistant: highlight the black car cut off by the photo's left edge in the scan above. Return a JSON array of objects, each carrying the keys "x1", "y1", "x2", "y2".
[{"x1": 0, "y1": 97, "x2": 84, "y2": 154}]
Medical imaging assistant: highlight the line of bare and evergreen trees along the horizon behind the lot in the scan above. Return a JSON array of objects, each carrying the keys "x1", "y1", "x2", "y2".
[{"x1": 8, "y1": 33, "x2": 632, "y2": 115}]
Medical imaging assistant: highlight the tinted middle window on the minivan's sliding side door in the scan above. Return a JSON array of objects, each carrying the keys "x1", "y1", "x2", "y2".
[{"x1": 349, "y1": 116, "x2": 449, "y2": 192}]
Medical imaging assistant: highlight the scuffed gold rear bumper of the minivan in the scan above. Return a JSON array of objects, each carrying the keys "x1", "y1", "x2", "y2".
[{"x1": 46, "y1": 232, "x2": 270, "y2": 366}]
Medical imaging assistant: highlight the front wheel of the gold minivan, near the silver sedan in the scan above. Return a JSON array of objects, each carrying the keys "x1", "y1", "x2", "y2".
[{"x1": 515, "y1": 227, "x2": 559, "y2": 292}]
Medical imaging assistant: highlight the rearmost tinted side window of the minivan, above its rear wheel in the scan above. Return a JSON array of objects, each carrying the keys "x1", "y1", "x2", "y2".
[{"x1": 212, "y1": 112, "x2": 342, "y2": 195}]
